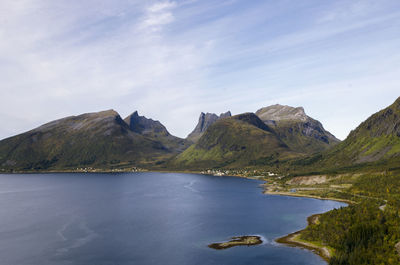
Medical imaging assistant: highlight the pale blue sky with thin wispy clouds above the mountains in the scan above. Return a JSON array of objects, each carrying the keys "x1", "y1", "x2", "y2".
[{"x1": 0, "y1": 0, "x2": 400, "y2": 139}]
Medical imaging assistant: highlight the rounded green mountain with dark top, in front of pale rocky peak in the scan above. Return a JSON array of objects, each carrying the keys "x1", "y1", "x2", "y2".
[{"x1": 173, "y1": 113, "x2": 297, "y2": 168}]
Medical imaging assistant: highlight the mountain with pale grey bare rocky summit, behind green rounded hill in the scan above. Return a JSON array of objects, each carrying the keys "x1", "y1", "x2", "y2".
[{"x1": 256, "y1": 104, "x2": 340, "y2": 154}]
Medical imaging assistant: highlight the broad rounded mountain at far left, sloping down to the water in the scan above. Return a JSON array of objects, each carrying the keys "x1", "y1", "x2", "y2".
[{"x1": 0, "y1": 110, "x2": 173, "y2": 170}]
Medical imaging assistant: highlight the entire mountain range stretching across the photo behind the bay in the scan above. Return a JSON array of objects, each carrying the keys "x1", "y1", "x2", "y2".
[{"x1": 0, "y1": 98, "x2": 400, "y2": 171}]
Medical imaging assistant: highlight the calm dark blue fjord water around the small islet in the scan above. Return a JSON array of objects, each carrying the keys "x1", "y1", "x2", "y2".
[{"x1": 0, "y1": 173, "x2": 343, "y2": 265}]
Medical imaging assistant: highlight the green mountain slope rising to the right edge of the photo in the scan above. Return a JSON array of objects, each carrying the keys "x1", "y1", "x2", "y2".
[{"x1": 294, "y1": 98, "x2": 400, "y2": 171}]
